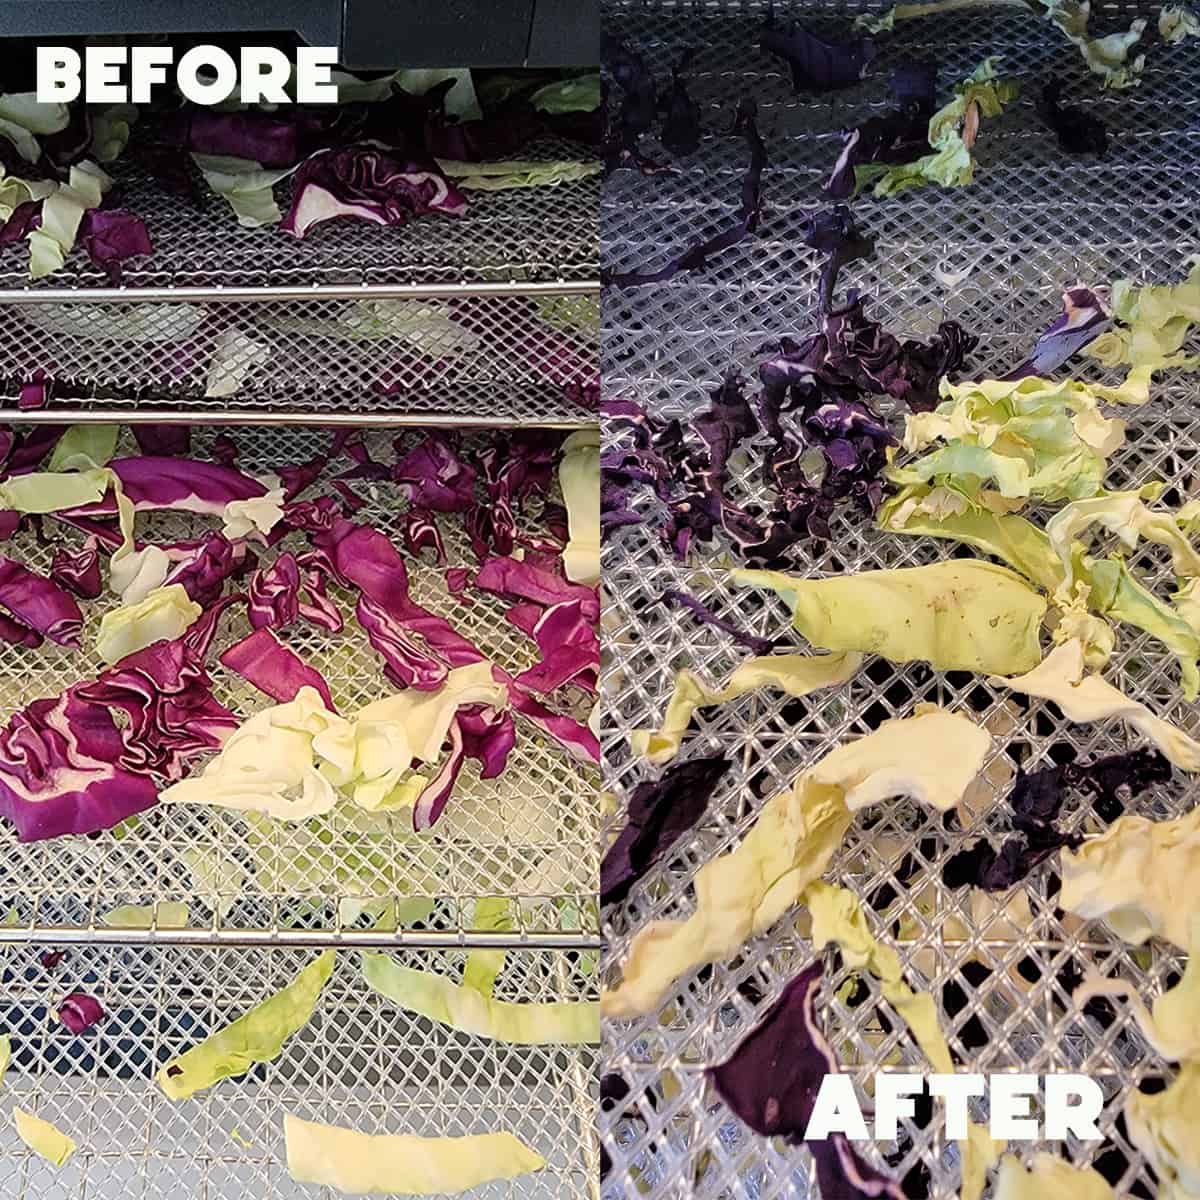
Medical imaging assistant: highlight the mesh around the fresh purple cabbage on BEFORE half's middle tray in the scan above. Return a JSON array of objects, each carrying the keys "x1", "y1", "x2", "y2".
[{"x1": 0, "y1": 428, "x2": 599, "y2": 944}]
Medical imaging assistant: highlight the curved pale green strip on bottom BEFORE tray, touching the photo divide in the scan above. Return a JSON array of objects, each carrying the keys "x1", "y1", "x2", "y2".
[{"x1": 362, "y1": 954, "x2": 600, "y2": 1045}]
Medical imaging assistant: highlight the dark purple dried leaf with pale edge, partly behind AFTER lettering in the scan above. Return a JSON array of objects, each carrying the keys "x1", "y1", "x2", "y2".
[{"x1": 706, "y1": 962, "x2": 904, "y2": 1200}]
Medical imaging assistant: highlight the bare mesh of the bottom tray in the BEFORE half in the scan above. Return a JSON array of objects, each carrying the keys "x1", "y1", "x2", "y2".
[{"x1": 0, "y1": 947, "x2": 596, "y2": 1200}]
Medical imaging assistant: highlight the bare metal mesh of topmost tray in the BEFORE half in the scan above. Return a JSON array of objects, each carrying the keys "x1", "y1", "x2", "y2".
[{"x1": 0, "y1": 147, "x2": 600, "y2": 299}]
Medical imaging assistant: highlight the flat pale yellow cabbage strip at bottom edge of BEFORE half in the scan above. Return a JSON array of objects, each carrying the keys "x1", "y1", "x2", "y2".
[{"x1": 283, "y1": 1112, "x2": 546, "y2": 1196}]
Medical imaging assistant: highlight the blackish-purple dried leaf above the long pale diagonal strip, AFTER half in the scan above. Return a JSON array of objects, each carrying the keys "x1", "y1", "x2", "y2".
[{"x1": 600, "y1": 755, "x2": 730, "y2": 905}]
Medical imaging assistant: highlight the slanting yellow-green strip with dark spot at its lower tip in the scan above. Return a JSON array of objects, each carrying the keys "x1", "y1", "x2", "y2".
[{"x1": 155, "y1": 950, "x2": 334, "y2": 1100}]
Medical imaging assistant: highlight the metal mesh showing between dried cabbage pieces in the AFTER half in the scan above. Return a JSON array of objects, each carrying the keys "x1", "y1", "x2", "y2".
[{"x1": 601, "y1": 4, "x2": 1200, "y2": 1200}]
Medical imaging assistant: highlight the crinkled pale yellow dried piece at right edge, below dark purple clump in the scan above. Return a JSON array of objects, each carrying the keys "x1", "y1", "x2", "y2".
[{"x1": 1058, "y1": 809, "x2": 1200, "y2": 949}]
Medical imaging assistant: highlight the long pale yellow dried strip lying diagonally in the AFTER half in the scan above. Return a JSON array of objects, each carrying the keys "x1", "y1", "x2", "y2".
[{"x1": 600, "y1": 706, "x2": 991, "y2": 1018}]
